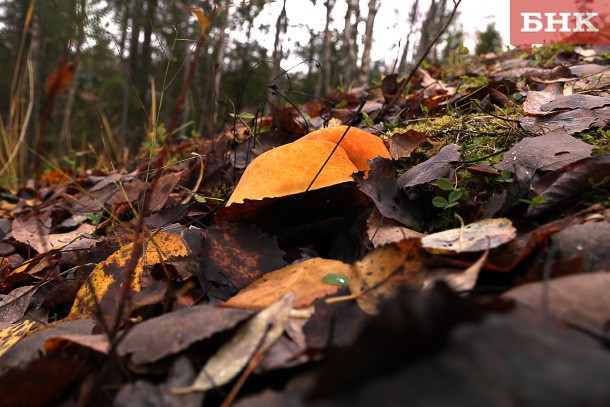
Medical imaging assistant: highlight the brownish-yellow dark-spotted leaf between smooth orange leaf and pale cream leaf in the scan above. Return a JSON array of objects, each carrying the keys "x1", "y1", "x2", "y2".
[{"x1": 349, "y1": 238, "x2": 424, "y2": 315}]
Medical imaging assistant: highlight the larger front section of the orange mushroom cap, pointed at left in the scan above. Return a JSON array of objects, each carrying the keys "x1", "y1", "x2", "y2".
[{"x1": 227, "y1": 138, "x2": 358, "y2": 206}]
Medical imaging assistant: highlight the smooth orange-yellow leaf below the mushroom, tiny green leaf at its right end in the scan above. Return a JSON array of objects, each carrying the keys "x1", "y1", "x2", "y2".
[{"x1": 223, "y1": 258, "x2": 352, "y2": 308}]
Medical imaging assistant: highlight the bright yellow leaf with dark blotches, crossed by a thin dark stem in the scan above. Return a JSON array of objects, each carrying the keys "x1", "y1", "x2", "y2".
[{"x1": 69, "y1": 232, "x2": 189, "y2": 318}]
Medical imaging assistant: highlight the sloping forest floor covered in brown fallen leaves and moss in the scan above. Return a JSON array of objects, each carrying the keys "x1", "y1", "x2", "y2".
[{"x1": 0, "y1": 47, "x2": 610, "y2": 407}]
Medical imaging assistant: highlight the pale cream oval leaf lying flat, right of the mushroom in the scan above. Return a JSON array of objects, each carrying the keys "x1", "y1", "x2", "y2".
[{"x1": 421, "y1": 218, "x2": 517, "y2": 254}]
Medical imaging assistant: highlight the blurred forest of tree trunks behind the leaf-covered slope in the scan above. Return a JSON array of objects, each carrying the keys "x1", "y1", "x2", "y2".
[{"x1": 0, "y1": 0, "x2": 502, "y2": 185}]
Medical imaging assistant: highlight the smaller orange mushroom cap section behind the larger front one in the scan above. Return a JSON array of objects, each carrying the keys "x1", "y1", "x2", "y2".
[{"x1": 300, "y1": 126, "x2": 392, "y2": 172}]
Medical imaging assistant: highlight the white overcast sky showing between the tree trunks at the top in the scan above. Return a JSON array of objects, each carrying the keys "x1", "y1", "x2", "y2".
[{"x1": 249, "y1": 0, "x2": 509, "y2": 66}]
